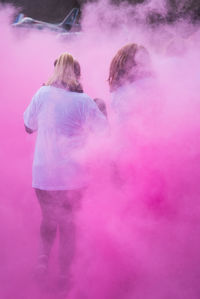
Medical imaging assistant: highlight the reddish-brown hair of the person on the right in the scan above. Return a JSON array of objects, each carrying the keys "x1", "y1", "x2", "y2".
[{"x1": 108, "y1": 43, "x2": 148, "y2": 91}]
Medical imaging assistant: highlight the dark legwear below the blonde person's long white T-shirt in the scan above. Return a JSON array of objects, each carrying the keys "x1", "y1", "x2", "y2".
[{"x1": 35, "y1": 189, "x2": 83, "y2": 275}]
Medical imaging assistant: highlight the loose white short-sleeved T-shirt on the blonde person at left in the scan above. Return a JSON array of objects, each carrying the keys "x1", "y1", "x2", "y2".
[{"x1": 24, "y1": 86, "x2": 105, "y2": 190}]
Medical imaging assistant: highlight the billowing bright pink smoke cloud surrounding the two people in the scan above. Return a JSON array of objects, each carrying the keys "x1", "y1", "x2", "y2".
[{"x1": 0, "y1": 1, "x2": 200, "y2": 299}]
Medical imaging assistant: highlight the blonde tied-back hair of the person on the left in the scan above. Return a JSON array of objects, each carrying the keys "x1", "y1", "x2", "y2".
[{"x1": 46, "y1": 52, "x2": 83, "y2": 92}]
